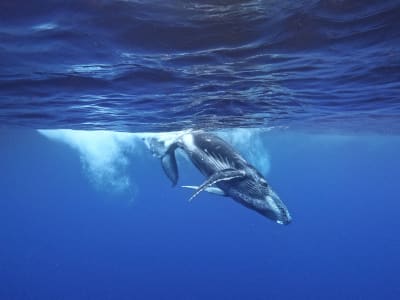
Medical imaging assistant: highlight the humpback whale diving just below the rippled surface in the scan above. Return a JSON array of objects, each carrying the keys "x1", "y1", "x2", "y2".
[{"x1": 161, "y1": 131, "x2": 291, "y2": 224}]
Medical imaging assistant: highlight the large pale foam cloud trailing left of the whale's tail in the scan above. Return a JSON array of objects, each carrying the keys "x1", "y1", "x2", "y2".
[{"x1": 39, "y1": 129, "x2": 186, "y2": 194}]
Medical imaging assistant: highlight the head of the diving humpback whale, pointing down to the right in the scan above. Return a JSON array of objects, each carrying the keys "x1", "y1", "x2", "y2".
[{"x1": 231, "y1": 172, "x2": 292, "y2": 225}]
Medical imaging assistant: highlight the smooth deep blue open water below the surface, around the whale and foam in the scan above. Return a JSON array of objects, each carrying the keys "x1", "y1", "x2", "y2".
[{"x1": 0, "y1": 131, "x2": 400, "y2": 299}]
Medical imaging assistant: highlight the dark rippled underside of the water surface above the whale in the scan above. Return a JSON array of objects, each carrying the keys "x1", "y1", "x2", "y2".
[{"x1": 0, "y1": 0, "x2": 400, "y2": 133}]
